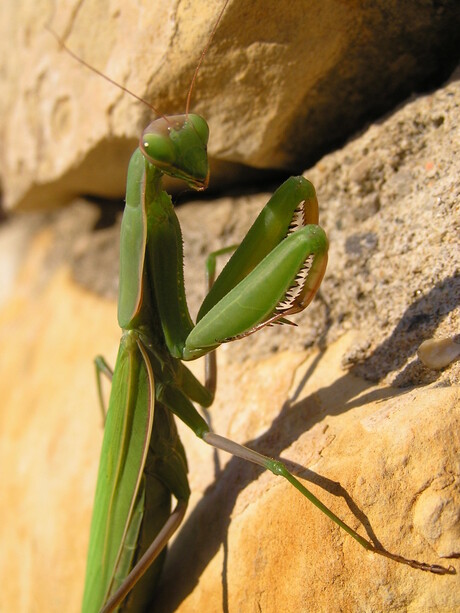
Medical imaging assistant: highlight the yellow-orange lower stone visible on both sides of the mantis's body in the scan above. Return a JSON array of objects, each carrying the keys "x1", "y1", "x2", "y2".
[{"x1": 0, "y1": 206, "x2": 460, "y2": 613}]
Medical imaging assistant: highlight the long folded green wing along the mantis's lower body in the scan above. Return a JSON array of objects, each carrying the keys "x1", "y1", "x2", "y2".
[{"x1": 83, "y1": 333, "x2": 154, "y2": 613}]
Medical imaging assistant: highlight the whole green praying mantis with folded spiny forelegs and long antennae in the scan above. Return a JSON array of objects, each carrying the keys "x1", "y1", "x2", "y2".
[{"x1": 49, "y1": 0, "x2": 450, "y2": 613}]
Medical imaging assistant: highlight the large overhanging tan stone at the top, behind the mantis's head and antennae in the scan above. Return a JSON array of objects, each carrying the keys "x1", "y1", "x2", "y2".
[{"x1": 0, "y1": 0, "x2": 460, "y2": 209}]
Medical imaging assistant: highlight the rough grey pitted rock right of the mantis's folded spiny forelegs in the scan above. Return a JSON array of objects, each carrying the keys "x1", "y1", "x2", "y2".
[{"x1": 306, "y1": 71, "x2": 460, "y2": 386}]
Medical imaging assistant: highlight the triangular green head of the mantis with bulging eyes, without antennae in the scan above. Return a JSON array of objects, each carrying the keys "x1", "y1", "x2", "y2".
[{"x1": 139, "y1": 113, "x2": 209, "y2": 190}]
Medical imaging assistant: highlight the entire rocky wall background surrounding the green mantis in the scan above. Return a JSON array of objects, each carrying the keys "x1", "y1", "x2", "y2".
[{"x1": 0, "y1": 0, "x2": 460, "y2": 613}]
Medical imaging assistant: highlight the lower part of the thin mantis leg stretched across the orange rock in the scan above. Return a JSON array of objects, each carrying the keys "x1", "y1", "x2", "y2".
[{"x1": 202, "y1": 432, "x2": 455, "y2": 575}]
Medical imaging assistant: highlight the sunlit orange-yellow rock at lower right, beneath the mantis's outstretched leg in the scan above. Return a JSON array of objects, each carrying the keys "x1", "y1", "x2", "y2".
[{"x1": 152, "y1": 334, "x2": 460, "y2": 613}]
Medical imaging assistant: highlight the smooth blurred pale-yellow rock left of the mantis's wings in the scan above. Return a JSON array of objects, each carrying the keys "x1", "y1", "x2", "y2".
[{"x1": 0, "y1": 226, "x2": 119, "y2": 613}]
